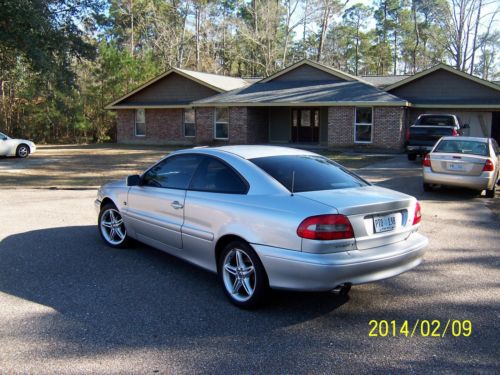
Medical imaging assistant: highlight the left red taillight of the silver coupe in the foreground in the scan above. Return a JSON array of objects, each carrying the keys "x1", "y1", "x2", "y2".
[{"x1": 297, "y1": 215, "x2": 354, "y2": 240}]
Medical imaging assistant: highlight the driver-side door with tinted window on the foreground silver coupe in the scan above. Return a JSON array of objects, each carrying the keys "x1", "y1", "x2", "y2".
[{"x1": 126, "y1": 154, "x2": 202, "y2": 250}]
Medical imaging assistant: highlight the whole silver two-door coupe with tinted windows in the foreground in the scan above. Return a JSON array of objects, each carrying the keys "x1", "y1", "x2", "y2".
[{"x1": 95, "y1": 146, "x2": 427, "y2": 308}]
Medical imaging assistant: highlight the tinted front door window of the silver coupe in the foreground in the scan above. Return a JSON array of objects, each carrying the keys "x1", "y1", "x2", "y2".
[{"x1": 143, "y1": 155, "x2": 202, "y2": 189}]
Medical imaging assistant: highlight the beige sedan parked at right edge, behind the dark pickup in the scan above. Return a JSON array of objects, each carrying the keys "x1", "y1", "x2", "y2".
[{"x1": 423, "y1": 137, "x2": 499, "y2": 198}]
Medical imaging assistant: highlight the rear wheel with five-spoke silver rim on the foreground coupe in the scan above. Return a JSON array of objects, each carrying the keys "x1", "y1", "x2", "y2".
[{"x1": 218, "y1": 241, "x2": 269, "y2": 309}]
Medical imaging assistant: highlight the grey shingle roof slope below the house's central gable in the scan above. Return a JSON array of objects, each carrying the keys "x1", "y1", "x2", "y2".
[{"x1": 193, "y1": 81, "x2": 407, "y2": 106}]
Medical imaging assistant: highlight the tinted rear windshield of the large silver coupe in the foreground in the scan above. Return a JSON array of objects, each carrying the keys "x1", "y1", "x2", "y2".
[{"x1": 250, "y1": 155, "x2": 369, "y2": 193}]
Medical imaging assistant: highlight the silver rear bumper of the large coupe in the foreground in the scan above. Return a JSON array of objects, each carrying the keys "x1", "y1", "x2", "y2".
[{"x1": 252, "y1": 233, "x2": 428, "y2": 291}]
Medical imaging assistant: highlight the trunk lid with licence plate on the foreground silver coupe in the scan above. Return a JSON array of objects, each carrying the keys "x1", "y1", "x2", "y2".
[{"x1": 296, "y1": 186, "x2": 416, "y2": 250}]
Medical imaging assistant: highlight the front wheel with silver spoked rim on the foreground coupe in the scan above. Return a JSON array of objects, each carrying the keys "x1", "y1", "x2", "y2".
[{"x1": 97, "y1": 203, "x2": 130, "y2": 248}]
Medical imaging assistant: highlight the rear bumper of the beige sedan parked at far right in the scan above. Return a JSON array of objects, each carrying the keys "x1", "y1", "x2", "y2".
[{"x1": 423, "y1": 167, "x2": 496, "y2": 190}]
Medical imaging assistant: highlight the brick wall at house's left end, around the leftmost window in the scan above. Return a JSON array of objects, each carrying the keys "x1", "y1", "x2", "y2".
[{"x1": 116, "y1": 108, "x2": 195, "y2": 145}]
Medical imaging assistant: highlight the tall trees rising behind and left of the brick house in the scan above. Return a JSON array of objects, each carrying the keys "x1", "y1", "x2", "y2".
[{"x1": 0, "y1": 0, "x2": 500, "y2": 142}]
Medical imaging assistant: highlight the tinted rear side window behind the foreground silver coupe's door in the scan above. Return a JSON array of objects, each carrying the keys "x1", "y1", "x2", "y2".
[{"x1": 189, "y1": 157, "x2": 248, "y2": 194}]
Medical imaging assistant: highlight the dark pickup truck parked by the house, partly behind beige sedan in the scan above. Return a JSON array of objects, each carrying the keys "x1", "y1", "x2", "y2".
[{"x1": 406, "y1": 114, "x2": 469, "y2": 160}]
